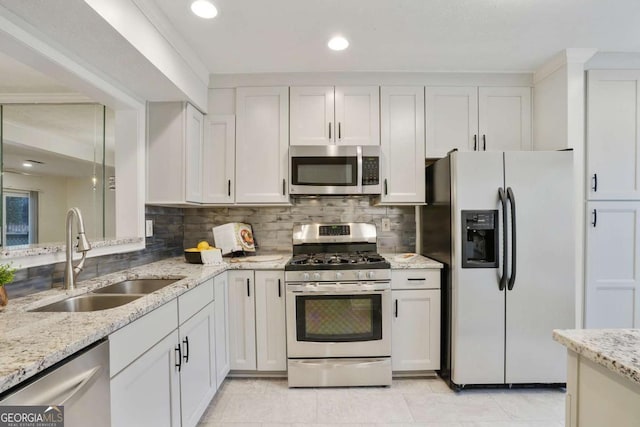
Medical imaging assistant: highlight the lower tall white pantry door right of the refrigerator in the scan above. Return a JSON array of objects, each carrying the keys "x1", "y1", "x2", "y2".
[{"x1": 585, "y1": 202, "x2": 640, "y2": 328}]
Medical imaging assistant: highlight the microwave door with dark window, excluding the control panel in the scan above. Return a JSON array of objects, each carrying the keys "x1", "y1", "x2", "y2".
[{"x1": 289, "y1": 145, "x2": 362, "y2": 195}]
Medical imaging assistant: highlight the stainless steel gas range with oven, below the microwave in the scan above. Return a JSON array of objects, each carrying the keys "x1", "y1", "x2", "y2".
[{"x1": 285, "y1": 223, "x2": 391, "y2": 387}]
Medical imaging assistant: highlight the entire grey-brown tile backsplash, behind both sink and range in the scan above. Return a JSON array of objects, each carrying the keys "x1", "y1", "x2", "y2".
[{"x1": 6, "y1": 197, "x2": 416, "y2": 298}]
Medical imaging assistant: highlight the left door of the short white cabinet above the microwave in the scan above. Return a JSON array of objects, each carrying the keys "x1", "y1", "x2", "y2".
[{"x1": 290, "y1": 86, "x2": 336, "y2": 145}]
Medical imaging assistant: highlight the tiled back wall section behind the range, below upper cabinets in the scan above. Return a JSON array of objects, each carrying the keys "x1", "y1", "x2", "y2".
[{"x1": 184, "y1": 197, "x2": 416, "y2": 252}]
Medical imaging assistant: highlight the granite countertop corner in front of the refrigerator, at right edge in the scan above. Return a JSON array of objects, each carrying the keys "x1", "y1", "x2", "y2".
[{"x1": 553, "y1": 329, "x2": 640, "y2": 384}]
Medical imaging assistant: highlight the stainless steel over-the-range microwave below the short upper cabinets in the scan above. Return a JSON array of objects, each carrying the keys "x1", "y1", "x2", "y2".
[{"x1": 289, "y1": 145, "x2": 382, "y2": 195}]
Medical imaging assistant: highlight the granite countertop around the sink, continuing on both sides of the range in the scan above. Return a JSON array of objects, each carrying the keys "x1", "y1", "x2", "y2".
[{"x1": 0, "y1": 253, "x2": 442, "y2": 393}]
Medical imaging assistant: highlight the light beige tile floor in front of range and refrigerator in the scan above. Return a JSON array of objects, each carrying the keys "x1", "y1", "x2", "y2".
[{"x1": 199, "y1": 378, "x2": 565, "y2": 427}]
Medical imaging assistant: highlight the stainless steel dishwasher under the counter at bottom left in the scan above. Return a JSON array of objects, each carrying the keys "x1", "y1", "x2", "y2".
[{"x1": 0, "y1": 341, "x2": 111, "y2": 427}]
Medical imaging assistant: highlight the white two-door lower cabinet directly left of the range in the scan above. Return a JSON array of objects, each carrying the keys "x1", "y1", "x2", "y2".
[{"x1": 228, "y1": 270, "x2": 287, "y2": 371}]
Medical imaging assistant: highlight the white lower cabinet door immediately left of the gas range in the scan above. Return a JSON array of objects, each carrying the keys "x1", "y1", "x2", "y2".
[{"x1": 255, "y1": 271, "x2": 287, "y2": 371}]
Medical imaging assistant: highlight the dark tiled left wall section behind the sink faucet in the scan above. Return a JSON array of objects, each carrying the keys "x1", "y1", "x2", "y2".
[{"x1": 6, "y1": 206, "x2": 184, "y2": 298}]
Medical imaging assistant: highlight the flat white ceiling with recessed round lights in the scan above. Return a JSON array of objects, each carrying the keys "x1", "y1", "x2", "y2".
[{"x1": 151, "y1": 0, "x2": 640, "y2": 73}]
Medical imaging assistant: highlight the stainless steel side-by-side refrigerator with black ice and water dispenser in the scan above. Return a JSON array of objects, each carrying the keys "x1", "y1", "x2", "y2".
[{"x1": 421, "y1": 151, "x2": 576, "y2": 388}]
